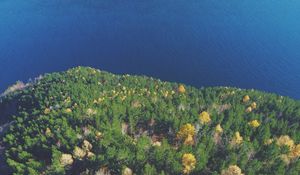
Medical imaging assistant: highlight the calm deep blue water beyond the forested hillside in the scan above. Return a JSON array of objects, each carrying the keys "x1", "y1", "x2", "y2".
[{"x1": 0, "y1": 0, "x2": 300, "y2": 99}]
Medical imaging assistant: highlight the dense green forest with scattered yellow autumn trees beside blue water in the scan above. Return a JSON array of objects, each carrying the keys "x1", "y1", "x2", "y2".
[{"x1": 0, "y1": 67, "x2": 300, "y2": 175}]
